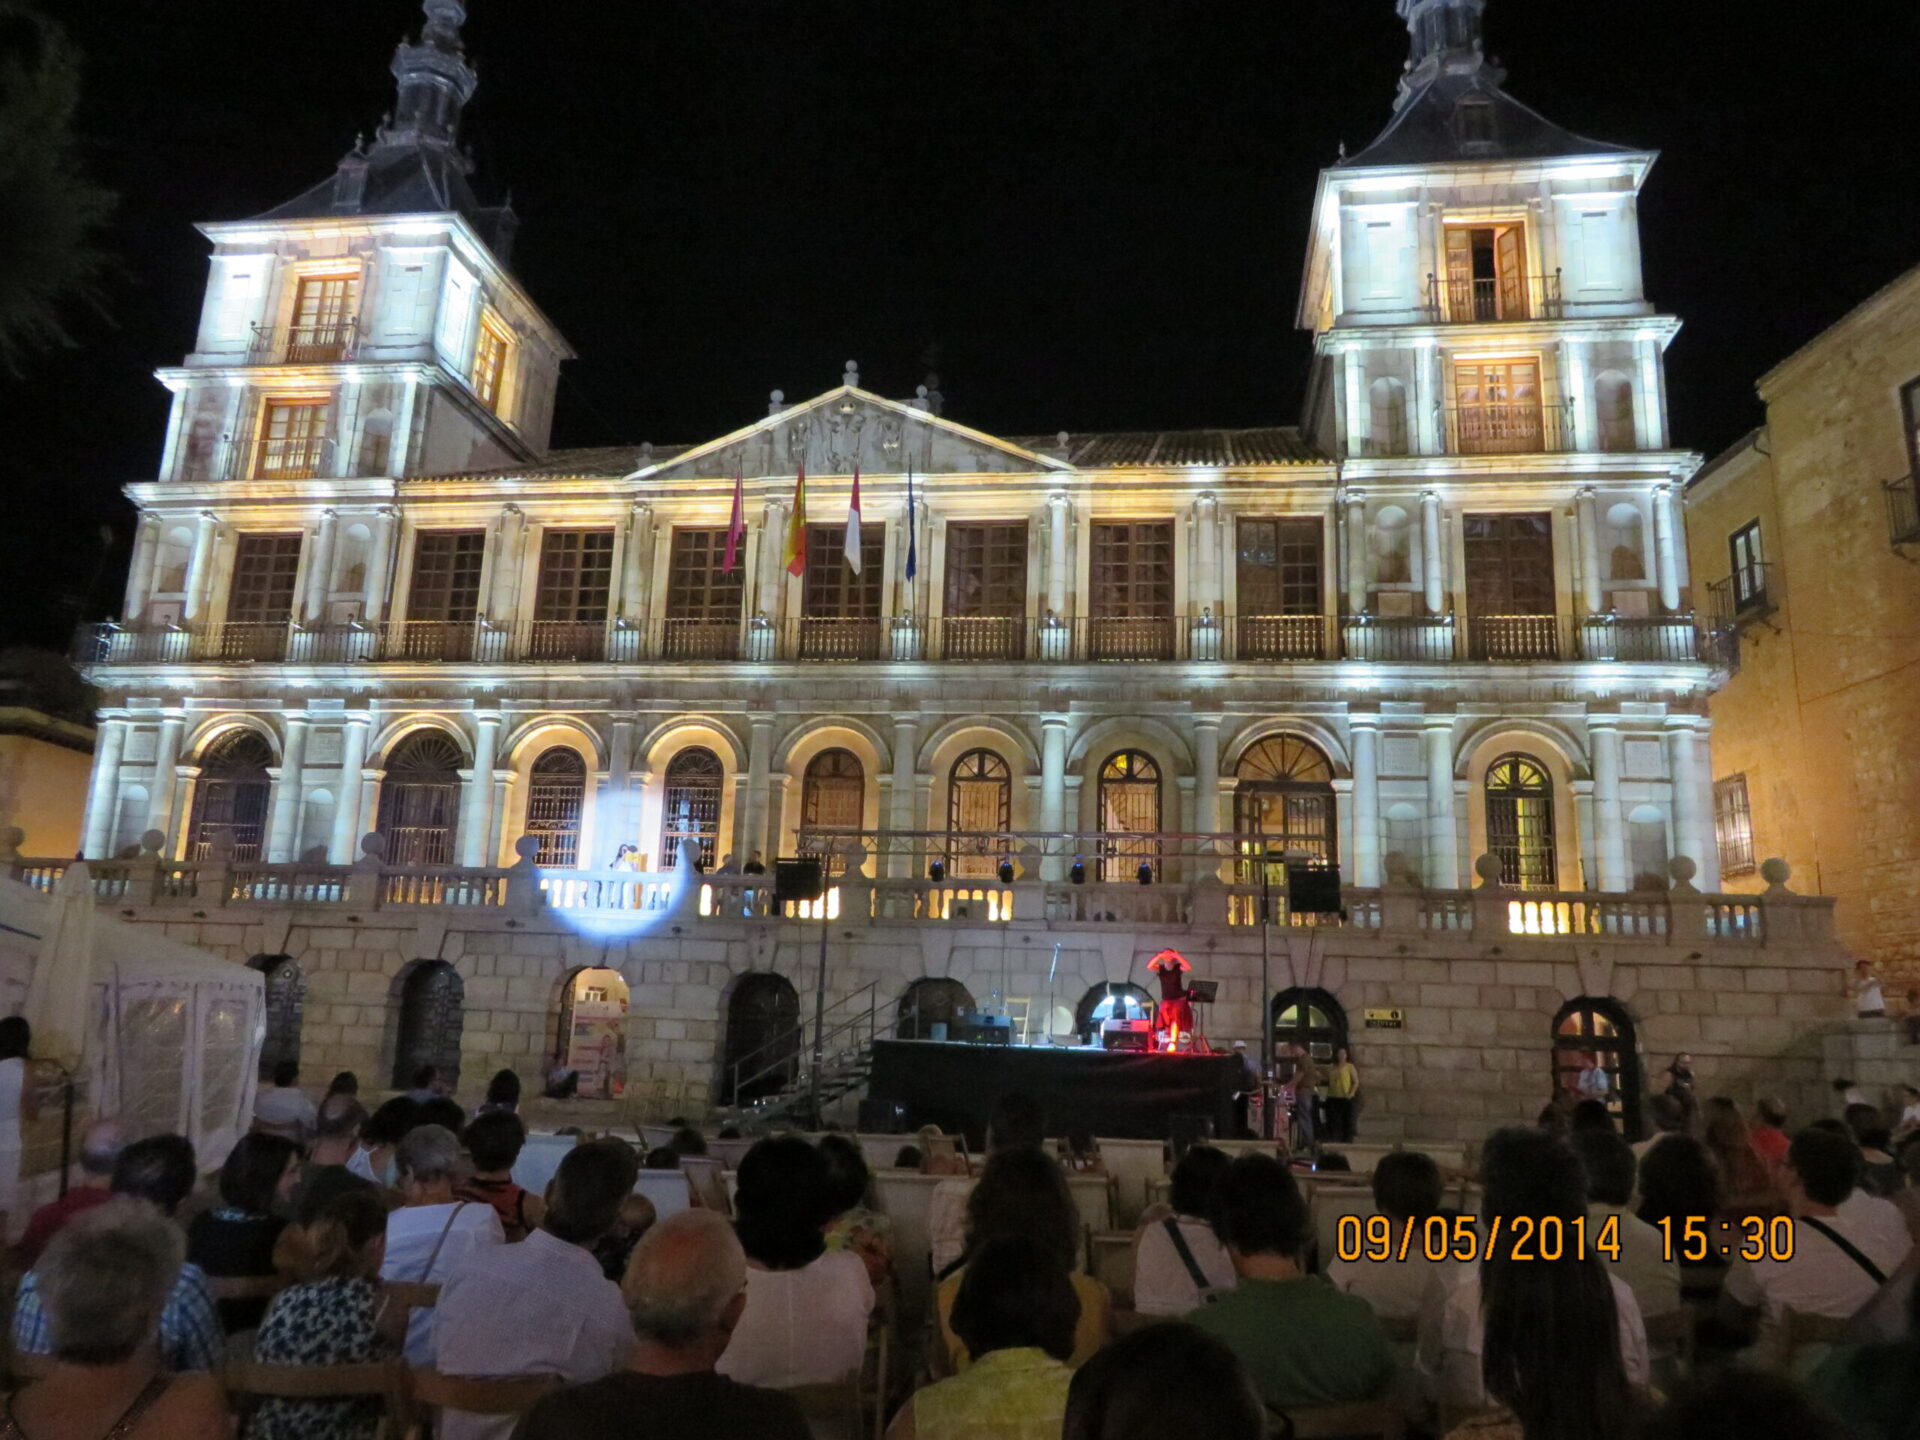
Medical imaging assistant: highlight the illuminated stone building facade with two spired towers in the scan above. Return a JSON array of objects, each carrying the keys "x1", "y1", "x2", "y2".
[{"x1": 52, "y1": 0, "x2": 1866, "y2": 1135}]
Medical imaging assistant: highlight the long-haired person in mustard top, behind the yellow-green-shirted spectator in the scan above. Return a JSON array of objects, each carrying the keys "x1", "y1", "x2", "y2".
[{"x1": 933, "y1": 1146, "x2": 1114, "y2": 1373}]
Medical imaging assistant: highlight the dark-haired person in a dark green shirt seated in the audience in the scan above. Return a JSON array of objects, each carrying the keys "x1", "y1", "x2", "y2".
[{"x1": 1187, "y1": 1154, "x2": 1394, "y2": 1411}]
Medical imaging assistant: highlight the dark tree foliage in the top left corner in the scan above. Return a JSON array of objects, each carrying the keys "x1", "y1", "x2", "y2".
[{"x1": 0, "y1": 0, "x2": 115, "y2": 374}]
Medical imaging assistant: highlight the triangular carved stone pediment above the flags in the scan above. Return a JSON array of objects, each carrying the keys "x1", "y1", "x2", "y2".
[{"x1": 632, "y1": 384, "x2": 1073, "y2": 482}]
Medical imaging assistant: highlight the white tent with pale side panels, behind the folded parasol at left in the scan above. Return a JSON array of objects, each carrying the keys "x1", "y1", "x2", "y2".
[{"x1": 0, "y1": 877, "x2": 267, "y2": 1167}]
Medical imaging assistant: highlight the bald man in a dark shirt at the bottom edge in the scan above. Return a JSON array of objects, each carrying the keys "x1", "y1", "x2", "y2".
[{"x1": 516, "y1": 1210, "x2": 810, "y2": 1440}]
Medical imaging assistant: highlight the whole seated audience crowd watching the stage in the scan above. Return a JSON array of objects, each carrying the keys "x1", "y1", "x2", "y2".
[{"x1": 0, "y1": 1058, "x2": 1920, "y2": 1440}]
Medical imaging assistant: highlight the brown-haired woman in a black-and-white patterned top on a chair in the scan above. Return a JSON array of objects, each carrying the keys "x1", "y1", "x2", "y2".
[{"x1": 248, "y1": 1185, "x2": 399, "y2": 1440}]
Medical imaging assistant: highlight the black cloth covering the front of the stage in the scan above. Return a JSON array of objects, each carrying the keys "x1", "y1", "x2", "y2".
[{"x1": 868, "y1": 1041, "x2": 1246, "y2": 1148}]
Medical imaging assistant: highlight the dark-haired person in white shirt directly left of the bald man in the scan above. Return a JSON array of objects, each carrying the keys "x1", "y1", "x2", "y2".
[{"x1": 434, "y1": 1140, "x2": 639, "y2": 1440}]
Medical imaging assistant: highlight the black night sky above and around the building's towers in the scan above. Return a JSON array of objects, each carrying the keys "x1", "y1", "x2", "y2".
[{"x1": 0, "y1": 0, "x2": 1920, "y2": 645}]
